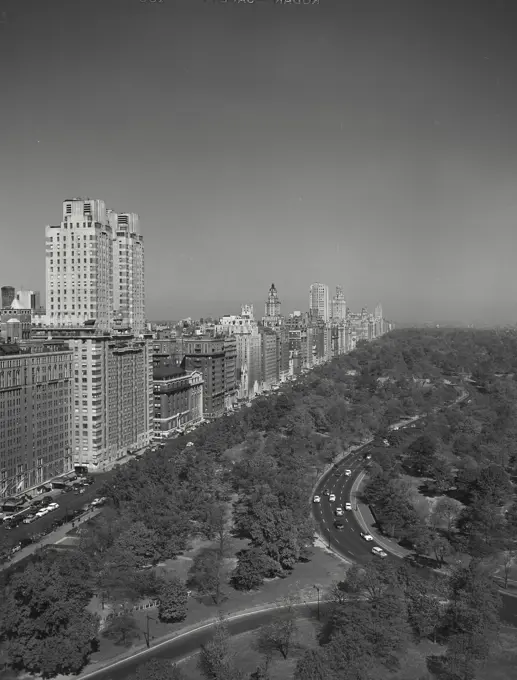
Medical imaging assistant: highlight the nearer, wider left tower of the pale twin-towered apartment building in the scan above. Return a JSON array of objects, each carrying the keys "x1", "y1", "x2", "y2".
[{"x1": 45, "y1": 198, "x2": 113, "y2": 330}]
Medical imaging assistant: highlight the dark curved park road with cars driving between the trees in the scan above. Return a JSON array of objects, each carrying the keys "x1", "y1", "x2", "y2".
[{"x1": 311, "y1": 393, "x2": 517, "y2": 626}]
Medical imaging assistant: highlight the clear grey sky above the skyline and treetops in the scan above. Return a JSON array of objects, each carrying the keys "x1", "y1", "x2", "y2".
[{"x1": 0, "y1": 0, "x2": 517, "y2": 323}]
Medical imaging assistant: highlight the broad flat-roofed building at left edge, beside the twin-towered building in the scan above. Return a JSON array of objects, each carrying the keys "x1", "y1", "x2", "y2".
[{"x1": 0, "y1": 341, "x2": 73, "y2": 499}]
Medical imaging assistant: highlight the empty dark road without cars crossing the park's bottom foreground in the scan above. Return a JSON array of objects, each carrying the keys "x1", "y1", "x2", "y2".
[{"x1": 79, "y1": 602, "x2": 320, "y2": 680}]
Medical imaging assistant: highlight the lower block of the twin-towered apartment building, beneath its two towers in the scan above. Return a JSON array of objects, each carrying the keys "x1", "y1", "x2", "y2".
[{"x1": 33, "y1": 326, "x2": 154, "y2": 470}]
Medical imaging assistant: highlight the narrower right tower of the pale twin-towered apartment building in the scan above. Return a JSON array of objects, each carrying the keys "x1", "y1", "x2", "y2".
[{"x1": 111, "y1": 213, "x2": 145, "y2": 335}]
